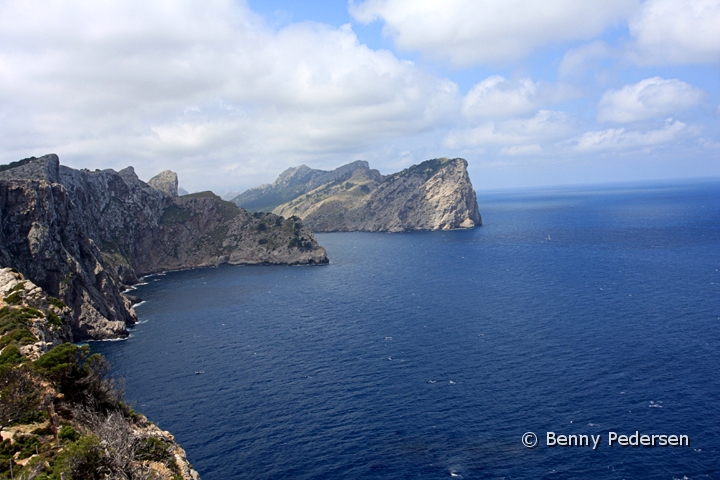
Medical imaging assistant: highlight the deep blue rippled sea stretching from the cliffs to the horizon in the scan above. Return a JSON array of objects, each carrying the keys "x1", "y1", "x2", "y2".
[{"x1": 92, "y1": 182, "x2": 720, "y2": 480}]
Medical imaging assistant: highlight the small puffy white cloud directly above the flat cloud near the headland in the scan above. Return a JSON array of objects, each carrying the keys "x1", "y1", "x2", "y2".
[{"x1": 462, "y1": 75, "x2": 571, "y2": 118}]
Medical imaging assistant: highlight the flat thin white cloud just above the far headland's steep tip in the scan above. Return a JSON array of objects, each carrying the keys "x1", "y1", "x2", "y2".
[{"x1": 444, "y1": 110, "x2": 574, "y2": 149}]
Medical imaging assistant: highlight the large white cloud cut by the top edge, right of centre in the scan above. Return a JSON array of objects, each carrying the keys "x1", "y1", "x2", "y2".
[{"x1": 350, "y1": 0, "x2": 639, "y2": 66}]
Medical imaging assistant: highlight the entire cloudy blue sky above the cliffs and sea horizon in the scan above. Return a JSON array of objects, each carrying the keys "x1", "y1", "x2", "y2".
[{"x1": 0, "y1": 0, "x2": 720, "y2": 194}]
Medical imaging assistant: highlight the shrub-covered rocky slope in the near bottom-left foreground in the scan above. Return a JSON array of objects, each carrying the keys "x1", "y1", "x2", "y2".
[{"x1": 0, "y1": 268, "x2": 199, "y2": 480}]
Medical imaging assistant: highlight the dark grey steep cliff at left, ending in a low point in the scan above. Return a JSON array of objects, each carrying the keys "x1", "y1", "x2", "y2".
[{"x1": 0, "y1": 155, "x2": 328, "y2": 341}]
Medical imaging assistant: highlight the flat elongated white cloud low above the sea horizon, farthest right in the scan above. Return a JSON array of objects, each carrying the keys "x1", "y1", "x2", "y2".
[{"x1": 570, "y1": 119, "x2": 698, "y2": 152}]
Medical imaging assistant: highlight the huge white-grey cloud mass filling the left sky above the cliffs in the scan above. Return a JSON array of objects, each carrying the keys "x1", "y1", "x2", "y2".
[{"x1": 0, "y1": 0, "x2": 460, "y2": 191}]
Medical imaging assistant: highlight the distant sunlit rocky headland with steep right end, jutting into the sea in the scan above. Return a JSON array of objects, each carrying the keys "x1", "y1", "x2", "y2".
[{"x1": 234, "y1": 158, "x2": 482, "y2": 232}]
